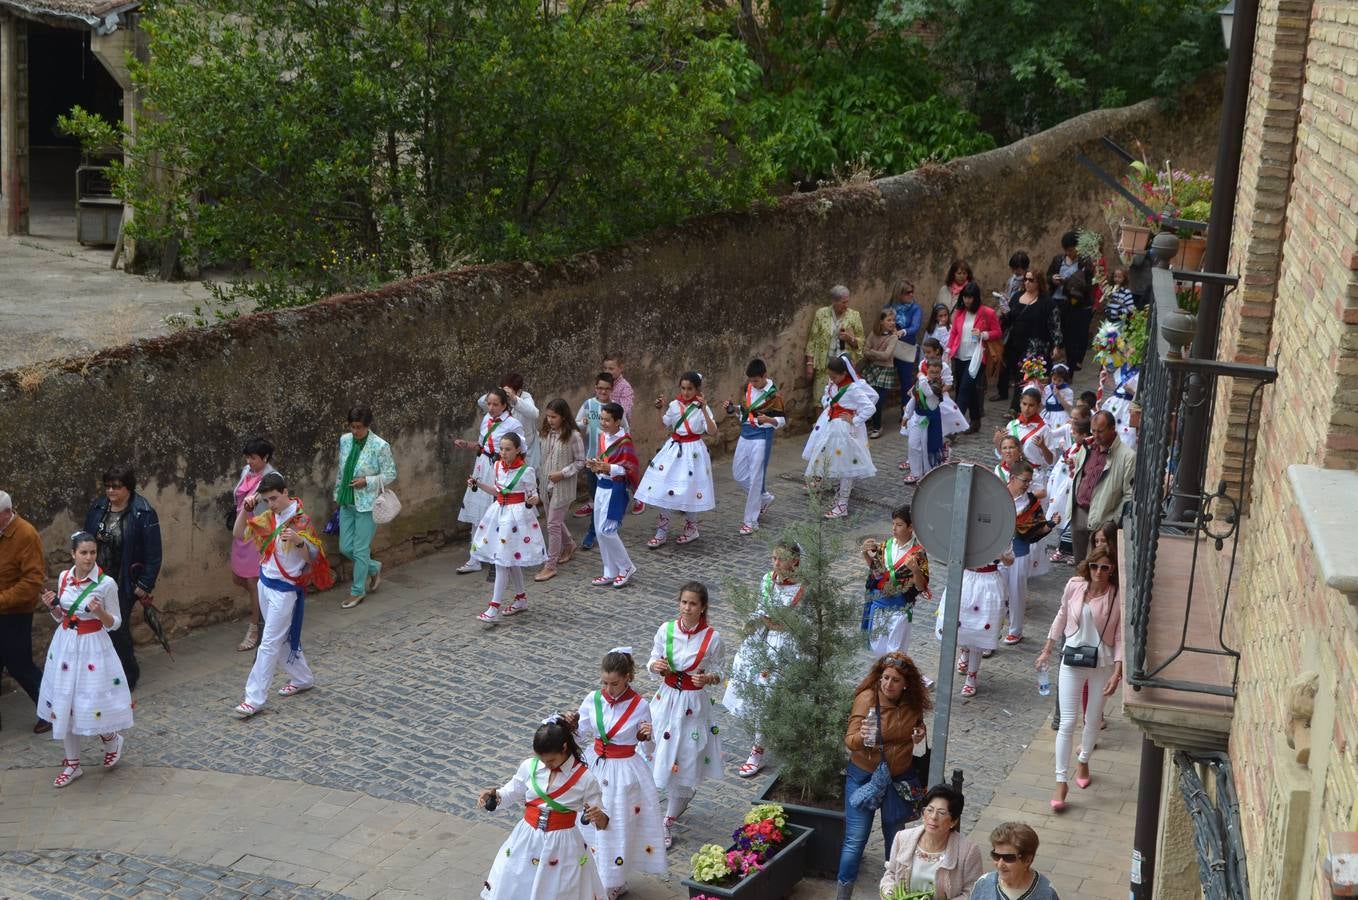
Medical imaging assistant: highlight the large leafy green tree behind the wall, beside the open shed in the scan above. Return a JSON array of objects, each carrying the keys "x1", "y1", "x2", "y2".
[{"x1": 120, "y1": 0, "x2": 773, "y2": 305}]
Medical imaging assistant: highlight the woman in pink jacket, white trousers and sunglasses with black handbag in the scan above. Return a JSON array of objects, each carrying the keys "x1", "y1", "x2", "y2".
[{"x1": 1036, "y1": 547, "x2": 1122, "y2": 813}]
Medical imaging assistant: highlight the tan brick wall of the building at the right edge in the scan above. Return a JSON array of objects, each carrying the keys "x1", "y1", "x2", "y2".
[{"x1": 1214, "y1": 0, "x2": 1358, "y2": 899}]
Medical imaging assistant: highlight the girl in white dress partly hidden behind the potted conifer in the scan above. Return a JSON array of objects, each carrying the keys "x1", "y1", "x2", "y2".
[{"x1": 721, "y1": 540, "x2": 805, "y2": 778}]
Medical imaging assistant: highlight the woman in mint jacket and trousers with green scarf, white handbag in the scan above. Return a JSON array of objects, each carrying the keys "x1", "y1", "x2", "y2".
[{"x1": 331, "y1": 406, "x2": 397, "y2": 610}]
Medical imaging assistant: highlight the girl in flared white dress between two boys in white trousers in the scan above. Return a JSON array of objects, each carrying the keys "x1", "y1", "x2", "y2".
[{"x1": 637, "y1": 372, "x2": 717, "y2": 550}]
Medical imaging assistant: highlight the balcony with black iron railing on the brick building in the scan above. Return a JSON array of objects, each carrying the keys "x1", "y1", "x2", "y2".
[{"x1": 1119, "y1": 269, "x2": 1278, "y2": 753}]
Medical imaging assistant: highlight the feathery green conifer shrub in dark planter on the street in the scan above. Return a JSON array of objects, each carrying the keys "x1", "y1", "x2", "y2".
[{"x1": 731, "y1": 509, "x2": 862, "y2": 874}]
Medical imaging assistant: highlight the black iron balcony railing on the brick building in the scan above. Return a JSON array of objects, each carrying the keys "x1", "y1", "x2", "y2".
[{"x1": 1124, "y1": 260, "x2": 1278, "y2": 698}]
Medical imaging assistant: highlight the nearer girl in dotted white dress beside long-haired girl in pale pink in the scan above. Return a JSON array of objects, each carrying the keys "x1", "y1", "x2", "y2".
[{"x1": 467, "y1": 433, "x2": 547, "y2": 624}]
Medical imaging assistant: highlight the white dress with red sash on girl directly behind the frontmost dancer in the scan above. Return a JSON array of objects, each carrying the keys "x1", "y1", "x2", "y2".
[{"x1": 576, "y1": 690, "x2": 667, "y2": 889}]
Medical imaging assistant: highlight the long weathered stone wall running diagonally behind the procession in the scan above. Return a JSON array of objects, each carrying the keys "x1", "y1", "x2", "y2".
[{"x1": 0, "y1": 73, "x2": 1219, "y2": 643}]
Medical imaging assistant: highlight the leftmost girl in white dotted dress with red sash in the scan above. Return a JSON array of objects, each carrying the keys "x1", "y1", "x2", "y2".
[{"x1": 38, "y1": 531, "x2": 132, "y2": 787}]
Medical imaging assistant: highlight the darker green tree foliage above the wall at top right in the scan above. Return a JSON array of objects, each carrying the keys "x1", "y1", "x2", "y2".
[{"x1": 888, "y1": 0, "x2": 1225, "y2": 141}]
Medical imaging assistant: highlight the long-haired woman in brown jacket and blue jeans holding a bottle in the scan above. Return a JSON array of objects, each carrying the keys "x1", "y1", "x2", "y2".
[{"x1": 835, "y1": 653, "x2": 933, "y2": 900}]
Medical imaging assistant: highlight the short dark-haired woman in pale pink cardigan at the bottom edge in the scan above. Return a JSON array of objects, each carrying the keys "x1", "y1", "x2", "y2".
[{"x1": 881, "y1": 785, "x2": 982, "y2": 900}]
